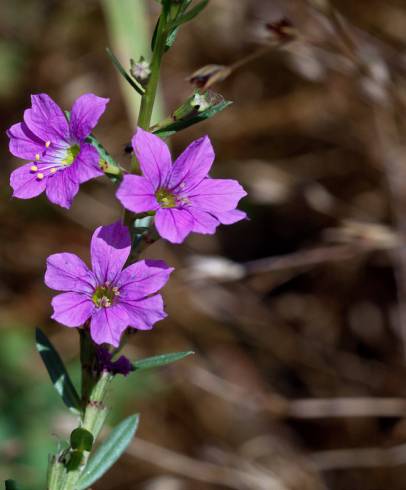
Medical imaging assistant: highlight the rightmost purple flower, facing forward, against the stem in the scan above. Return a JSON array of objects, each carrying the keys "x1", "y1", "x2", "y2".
[{"x1": 117, "y1": 128, "x2": 246, "y2": 243}]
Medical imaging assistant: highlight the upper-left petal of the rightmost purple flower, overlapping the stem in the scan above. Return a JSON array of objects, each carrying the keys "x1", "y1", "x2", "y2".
[{"x1": 132, "y1": 128, "x2": 172, "y2": 191}]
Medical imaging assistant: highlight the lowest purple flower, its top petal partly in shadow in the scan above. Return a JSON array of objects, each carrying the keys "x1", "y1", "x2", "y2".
[{"x1": 45, "y1": 222, "x2": 173, "y2": 347}]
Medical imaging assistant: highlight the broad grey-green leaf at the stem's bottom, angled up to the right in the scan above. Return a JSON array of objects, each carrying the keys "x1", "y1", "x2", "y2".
[{"x1": 78, "y1": 414, "x2": 139, "y2": 490}]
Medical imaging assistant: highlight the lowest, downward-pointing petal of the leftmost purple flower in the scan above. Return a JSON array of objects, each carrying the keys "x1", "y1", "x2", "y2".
[{"x1": 44, "y1": 167, "x2": 79, "y2": 209}]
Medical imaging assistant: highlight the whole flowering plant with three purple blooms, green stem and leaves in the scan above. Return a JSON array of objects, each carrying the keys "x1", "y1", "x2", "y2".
[{"x1": 6, "y1": 0, "x2": 246, "y2": 490}]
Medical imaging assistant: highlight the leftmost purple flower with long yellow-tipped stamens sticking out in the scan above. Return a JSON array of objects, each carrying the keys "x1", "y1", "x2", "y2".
[{"x1": 7, "y1": 94, "x2": 108, "y2": 208}]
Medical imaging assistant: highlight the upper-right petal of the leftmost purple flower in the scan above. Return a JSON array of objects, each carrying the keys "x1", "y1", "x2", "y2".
[{"x1": 69, "y1": 94, "x2": 109, "y2": 141}]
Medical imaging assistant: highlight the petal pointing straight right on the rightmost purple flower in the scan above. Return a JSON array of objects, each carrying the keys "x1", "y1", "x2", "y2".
[{"x1": 188, "y1": 179, "x2": 247, "y2": 212}]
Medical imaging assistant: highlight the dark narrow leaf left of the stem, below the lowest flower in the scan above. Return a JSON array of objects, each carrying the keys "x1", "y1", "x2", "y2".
[{"x1": 35, "y1": 328, "x2": 80, "y2": 413}]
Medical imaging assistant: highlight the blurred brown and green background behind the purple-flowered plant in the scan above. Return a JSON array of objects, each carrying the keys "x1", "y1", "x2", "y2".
[{"x1": 0, "y1": 0, "x2": 406, "y2": 490}]
